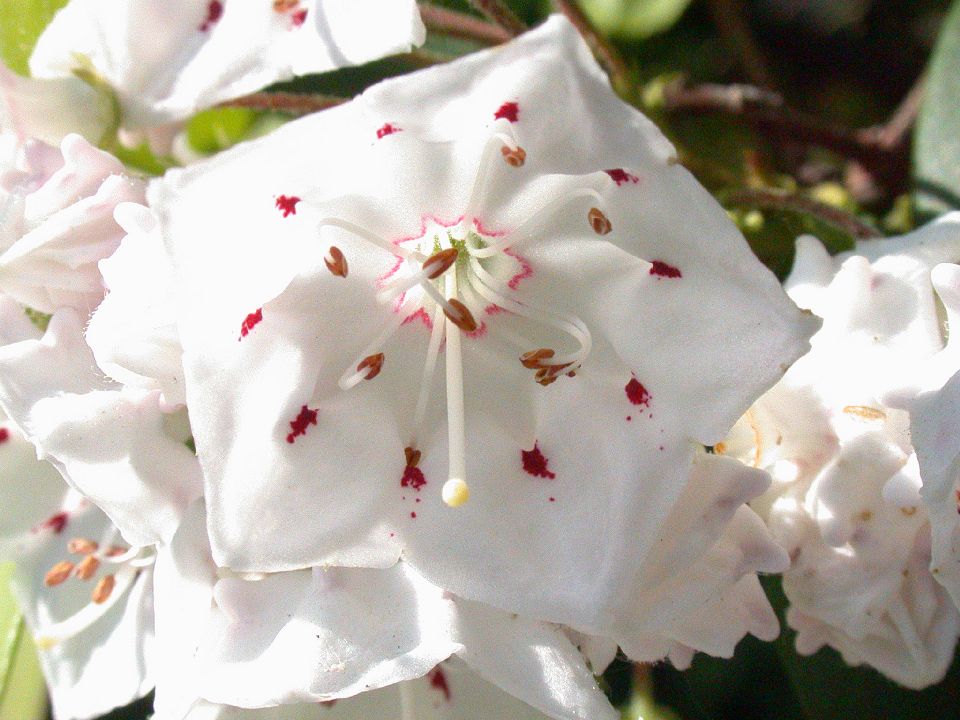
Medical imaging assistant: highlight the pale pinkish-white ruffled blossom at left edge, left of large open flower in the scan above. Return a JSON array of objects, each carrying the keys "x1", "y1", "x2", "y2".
[{"x1": 0, "y1": 135, "x2": 143, "y2": 313}]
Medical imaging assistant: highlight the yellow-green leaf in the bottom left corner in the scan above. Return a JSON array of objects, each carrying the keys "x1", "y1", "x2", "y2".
[{"x1": 0, "y1": 563, "x2": 47, "y2": 720}]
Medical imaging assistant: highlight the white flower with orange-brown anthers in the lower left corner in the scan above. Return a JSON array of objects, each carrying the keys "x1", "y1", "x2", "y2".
[{"x1": 0, "y1": 296, "x2": 153, "y2": 720}]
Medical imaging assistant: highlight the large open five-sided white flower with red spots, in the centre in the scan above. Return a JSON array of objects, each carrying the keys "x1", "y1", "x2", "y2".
[{"x1": 151, "y1": 18, "x2": 813, "y2": 655}]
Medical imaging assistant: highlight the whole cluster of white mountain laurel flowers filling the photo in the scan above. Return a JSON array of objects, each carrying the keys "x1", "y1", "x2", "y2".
[{"x1": 0, "y1": 0, "x2": 960, "y2": 720}]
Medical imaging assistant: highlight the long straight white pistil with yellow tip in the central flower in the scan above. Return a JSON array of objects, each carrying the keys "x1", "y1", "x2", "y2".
[{"x1": 441, "y1": 273, "x2": 475, "y2": 507}]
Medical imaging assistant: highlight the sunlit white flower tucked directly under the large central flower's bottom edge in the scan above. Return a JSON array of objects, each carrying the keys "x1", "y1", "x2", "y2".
[{"x1": 150, "y1": 502, "x2": 616, "y2": 720}]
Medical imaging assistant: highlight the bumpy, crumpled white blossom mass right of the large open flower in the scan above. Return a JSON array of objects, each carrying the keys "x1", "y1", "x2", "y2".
[{"x1": 718, "y1": 215, "x2": 960, "y2": 688}]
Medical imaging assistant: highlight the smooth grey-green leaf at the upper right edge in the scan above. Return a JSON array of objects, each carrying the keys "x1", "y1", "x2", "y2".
[{"x1": 913, "y1": 2, "x2": 960, "y2": 214}]
